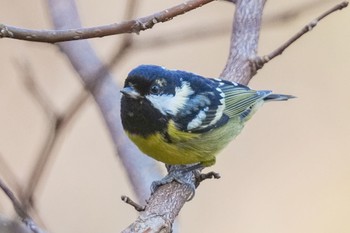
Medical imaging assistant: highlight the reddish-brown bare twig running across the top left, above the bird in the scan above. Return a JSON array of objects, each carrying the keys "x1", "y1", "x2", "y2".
[{"x1": 0, "y1": 0, "x2": 213, "y2": 43}]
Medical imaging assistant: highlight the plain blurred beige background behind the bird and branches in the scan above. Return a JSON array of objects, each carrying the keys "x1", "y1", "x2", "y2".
[{"x1": 0, "y1": 0, "x2": 350, "y2": 233}]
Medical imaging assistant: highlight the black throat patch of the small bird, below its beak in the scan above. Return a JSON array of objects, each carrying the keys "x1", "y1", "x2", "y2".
[{"x1": 121, "y1": 96, "x2": 168, "y2": 137}]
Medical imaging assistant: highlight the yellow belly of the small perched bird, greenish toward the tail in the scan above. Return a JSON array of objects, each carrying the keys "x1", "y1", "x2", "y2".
[{"x1": 128, "y1": 117, "x2": 243, "y2": 166}]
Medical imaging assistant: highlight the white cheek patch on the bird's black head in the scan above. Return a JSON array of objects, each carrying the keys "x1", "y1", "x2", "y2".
[{"x1": 146, "y1": 82, "x2": 194, "y2": 116}]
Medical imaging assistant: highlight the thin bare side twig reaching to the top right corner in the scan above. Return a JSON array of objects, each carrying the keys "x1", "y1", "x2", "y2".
[{"x1": 252, "y1": 1, "x2": 349, "y2": 72}]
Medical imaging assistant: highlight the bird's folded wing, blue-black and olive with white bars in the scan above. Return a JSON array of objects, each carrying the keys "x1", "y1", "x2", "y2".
[{"x1": 173, "y1": 79, "x2": 271, "y2": 133}]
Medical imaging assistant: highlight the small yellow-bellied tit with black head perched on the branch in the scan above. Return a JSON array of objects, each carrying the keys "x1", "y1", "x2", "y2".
[{"x1": 121, "y1": 65, "x2": 293, "y2": 193}]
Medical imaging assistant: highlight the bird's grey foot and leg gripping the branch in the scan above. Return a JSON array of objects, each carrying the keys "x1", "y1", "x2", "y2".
[{"x1": 151, "y1": 163, "x2": 204, "y2": 201}]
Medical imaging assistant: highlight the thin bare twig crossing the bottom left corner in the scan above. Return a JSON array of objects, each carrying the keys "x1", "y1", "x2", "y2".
[{"x1": 0, "y1": 179, "x2": 44, "y2": 233}]
